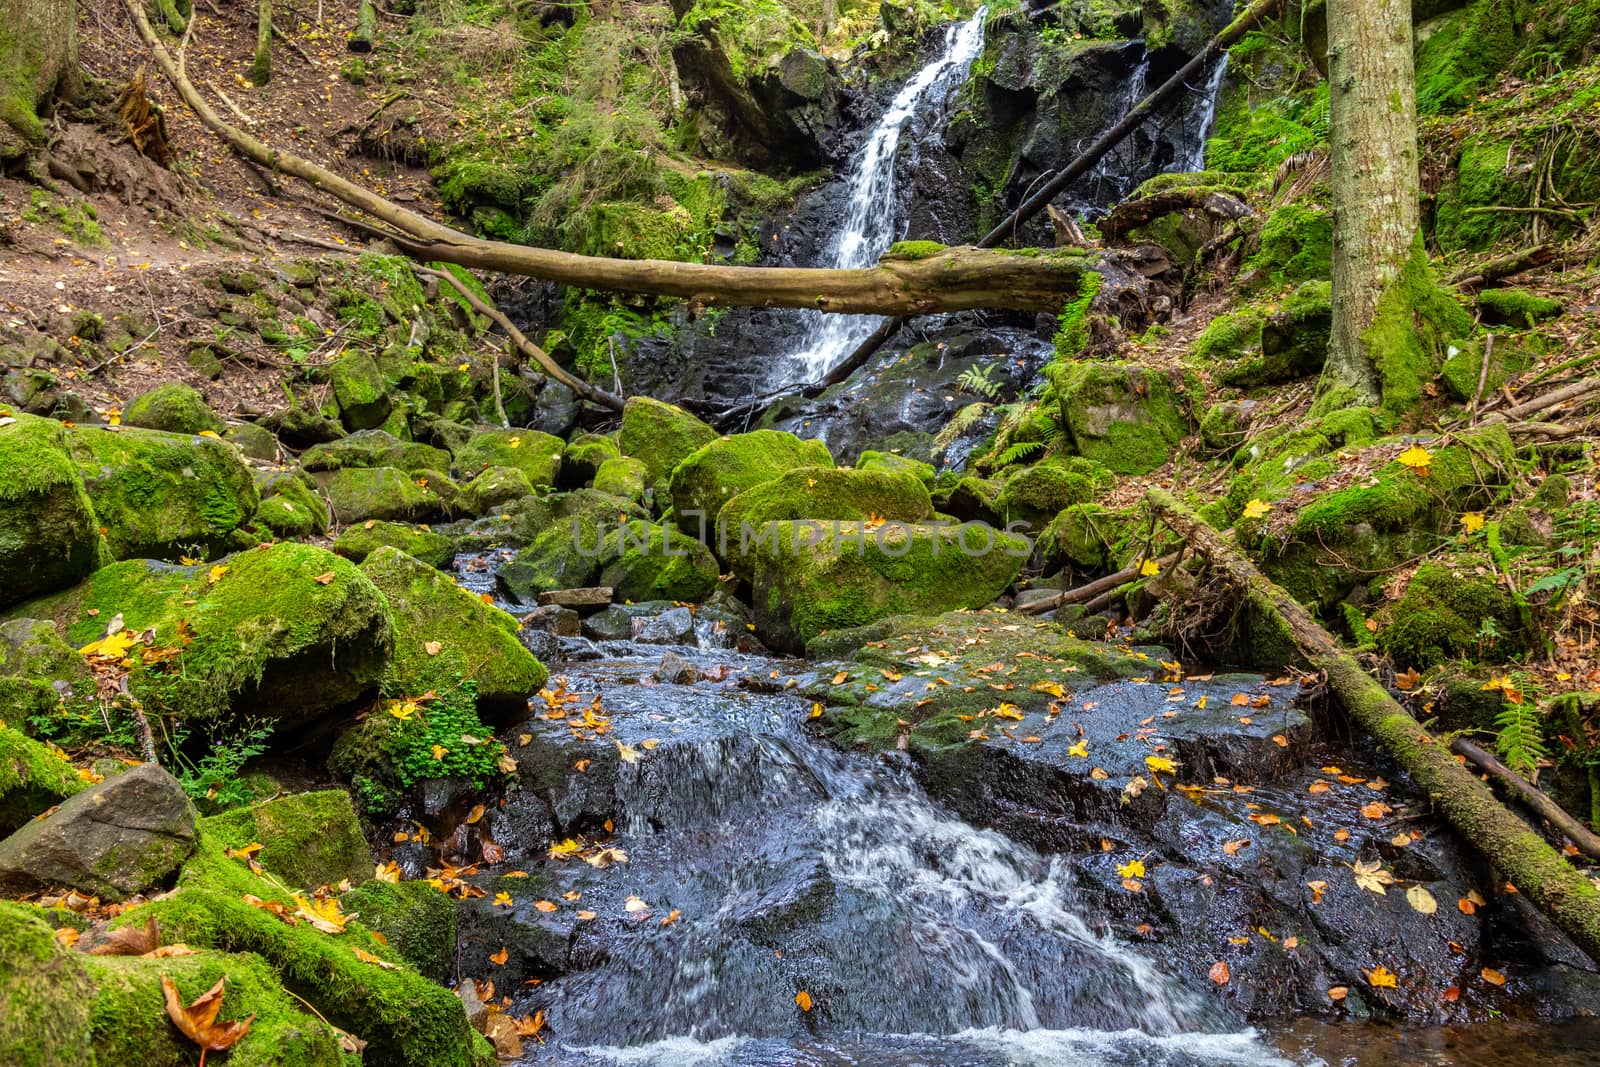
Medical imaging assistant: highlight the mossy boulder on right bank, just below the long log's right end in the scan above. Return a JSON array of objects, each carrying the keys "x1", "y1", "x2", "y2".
[{"x1": 1053, "y1": 360, "x2": 1189, "y2": 474}]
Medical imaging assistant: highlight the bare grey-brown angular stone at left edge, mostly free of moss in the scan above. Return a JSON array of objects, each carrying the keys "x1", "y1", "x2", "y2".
[{"x1": 0, "y1": 763, "x2": 195, "y2": 901}]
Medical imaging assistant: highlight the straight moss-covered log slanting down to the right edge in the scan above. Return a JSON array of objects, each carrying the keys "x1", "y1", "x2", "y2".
[{"x1": 1146, "y1": 490, "x2": 1600, "y2": 961}]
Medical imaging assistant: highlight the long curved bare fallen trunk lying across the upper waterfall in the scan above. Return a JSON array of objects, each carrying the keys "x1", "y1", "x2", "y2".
[{"x1": 125, "y1": 0, "x2": 1096, "y2": 315}]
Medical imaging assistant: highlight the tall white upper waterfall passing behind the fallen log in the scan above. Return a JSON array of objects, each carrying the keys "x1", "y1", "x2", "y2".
[{"x1": 789, "y1": 8, "x2": 987, "y2": 378}]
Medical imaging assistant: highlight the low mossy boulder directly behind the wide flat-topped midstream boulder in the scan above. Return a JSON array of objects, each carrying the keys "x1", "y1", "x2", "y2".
[{"x1": 712, "y1": 467, "x2": 933, "y2": 577}]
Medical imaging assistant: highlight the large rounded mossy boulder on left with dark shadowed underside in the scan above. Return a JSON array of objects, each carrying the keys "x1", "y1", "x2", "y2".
[{"x1": 14, "y1": 542, "x2": 394, "y2": 729}]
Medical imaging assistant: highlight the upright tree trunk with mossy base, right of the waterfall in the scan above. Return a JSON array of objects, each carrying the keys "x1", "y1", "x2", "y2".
[{"x1": 1318, "y1": 0, "x2": 1472, "y2": 419}]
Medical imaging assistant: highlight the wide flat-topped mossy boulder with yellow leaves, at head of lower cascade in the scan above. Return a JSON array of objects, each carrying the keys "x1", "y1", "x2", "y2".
[{"x1": 750, "y1": 520, "x2": 1030, "y2": 651}]
